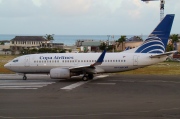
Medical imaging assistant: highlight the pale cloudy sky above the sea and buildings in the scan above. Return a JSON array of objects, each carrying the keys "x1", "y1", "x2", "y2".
[{"x1": 0, "y1": 0, "x2": 180, "y2": 35}]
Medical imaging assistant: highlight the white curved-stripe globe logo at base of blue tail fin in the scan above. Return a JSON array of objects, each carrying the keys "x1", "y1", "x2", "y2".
[{"x1": 135, "y1": 37, "x2": 165, "y2": 54}]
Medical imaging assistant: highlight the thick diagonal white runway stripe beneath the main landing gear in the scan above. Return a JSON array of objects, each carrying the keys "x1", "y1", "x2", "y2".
[{"x1": 61, "y1": 75, "x2": 109, "y2": 90}]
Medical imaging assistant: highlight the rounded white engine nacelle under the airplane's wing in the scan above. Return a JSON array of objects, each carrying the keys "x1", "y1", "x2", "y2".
[{"x1": 50, "y1": 68, "x2": 71, "y2": 79}]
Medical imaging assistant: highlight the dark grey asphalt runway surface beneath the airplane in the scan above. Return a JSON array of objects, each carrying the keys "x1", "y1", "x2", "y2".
[{"x1": 0, "y1": 74, "x2": 180, "y2": 119}]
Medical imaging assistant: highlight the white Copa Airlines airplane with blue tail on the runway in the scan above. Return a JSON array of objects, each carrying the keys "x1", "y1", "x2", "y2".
[{"x1": 4, "y1": 14, "x2": 175, "y2": 81}]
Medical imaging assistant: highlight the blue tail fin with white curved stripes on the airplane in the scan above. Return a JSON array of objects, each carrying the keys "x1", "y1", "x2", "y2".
[{"x1": 135, "y1": 14, "x2": 175, "y2": 54}]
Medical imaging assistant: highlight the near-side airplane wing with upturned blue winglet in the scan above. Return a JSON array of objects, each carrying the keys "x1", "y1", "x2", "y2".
[{"x1": 69, "y1": 50, "x2": 106, "y2": 73}]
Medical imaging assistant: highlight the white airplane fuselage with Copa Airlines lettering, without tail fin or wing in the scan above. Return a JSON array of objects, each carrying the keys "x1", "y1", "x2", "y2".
[{"x1": 5, "y1": 53, "x2": 167, "y2": 73}]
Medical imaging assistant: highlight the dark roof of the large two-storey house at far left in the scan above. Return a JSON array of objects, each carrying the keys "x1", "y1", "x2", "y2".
[{"x1": 11, "y1": 36, "x2": 46, "y2": 41}]
